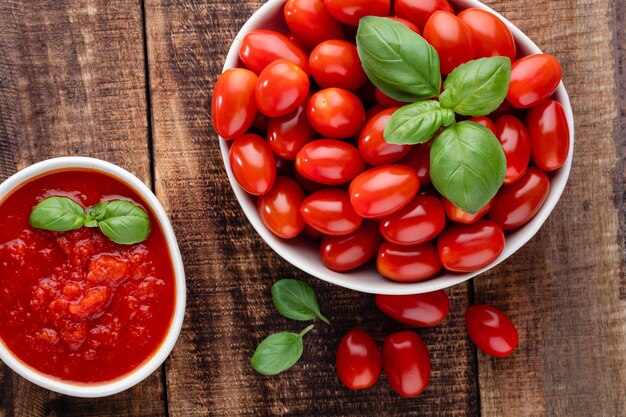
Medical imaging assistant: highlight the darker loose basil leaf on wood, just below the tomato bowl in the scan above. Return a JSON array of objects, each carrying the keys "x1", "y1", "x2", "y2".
[{"x1": 272, "y1": 279, "x2": 330, "y2": 324}]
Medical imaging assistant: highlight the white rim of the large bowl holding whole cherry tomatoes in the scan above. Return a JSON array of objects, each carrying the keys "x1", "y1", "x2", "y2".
[{"x1": 218, "y1": 0, "x2": 575, "y2": 295}]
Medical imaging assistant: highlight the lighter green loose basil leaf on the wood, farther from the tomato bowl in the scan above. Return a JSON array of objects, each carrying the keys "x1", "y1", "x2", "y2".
[{"x1": 250, "y1": 324, "x2": 314, "y2": 375}]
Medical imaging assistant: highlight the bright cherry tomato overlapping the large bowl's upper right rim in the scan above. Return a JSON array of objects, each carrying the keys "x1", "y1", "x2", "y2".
[{"x1": 506, "y1": 54, "x2": 562, "y2": 109}]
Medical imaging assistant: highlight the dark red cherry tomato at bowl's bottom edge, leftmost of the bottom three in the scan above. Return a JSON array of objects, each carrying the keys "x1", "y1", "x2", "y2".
[{"x1": 320, "y1": 221, "x2": 381, "y2": 272}]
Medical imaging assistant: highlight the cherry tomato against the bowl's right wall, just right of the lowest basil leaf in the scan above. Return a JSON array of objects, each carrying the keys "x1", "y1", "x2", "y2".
[{"x1": 489, "y1": 167, "x2": 550, "y2": 230}]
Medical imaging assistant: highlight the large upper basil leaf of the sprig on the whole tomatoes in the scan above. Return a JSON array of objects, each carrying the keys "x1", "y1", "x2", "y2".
[{"x1": 356, "y1": 16, "x2": 441, "y2": 102}]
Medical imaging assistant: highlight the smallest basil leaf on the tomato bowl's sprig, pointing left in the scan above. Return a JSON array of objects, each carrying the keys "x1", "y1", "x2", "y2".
[{"x1": 384, "y1": 100, "x2": 454, "y2": 145}]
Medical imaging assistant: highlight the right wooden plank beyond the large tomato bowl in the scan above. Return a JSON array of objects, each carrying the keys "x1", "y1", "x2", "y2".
[{"x1": 475, "y1": 0, "x2": 626, "y2": 417}]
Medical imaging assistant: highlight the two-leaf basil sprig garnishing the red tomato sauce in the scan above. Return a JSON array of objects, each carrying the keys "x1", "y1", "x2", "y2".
[{"x1": 29, "y1": 197, "x2": 150, "y2": 245}]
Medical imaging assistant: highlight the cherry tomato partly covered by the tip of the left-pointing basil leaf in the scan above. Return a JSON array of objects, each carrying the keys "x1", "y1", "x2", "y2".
[{"x1": 359, "y1": 107, "x2": 411, "y2": 165}]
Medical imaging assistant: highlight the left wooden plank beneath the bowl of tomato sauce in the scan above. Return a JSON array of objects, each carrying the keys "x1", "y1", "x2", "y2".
[{"x1": 0, "y1": 0, "x2": 166, "y2": 416}]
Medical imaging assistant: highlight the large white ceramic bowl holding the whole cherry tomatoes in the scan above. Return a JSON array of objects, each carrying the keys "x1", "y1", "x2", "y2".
[{"x1": 220, "y1": 0, "x2": 574, "y2": 294}]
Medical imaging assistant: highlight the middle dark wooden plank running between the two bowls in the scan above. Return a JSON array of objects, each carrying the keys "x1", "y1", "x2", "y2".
[{"x1": 146, "y1": 0, "x2": 478, "y2": 417}]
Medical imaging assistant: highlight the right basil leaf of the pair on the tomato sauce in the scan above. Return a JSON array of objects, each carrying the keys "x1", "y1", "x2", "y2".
[{"x1": 89, "y1": 200, "x2": 150, "y2": 245}]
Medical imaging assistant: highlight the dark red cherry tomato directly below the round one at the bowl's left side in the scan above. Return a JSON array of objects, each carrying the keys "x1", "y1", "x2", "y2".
[{"x1": 267, "y1": 105, "x2": 316, "y2": 160}]
